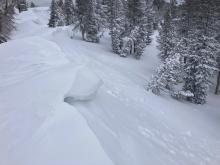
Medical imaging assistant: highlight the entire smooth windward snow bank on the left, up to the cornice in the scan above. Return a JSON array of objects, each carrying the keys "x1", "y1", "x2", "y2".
[{"x1": 0, "y1": 37, "x2": 113, "y2": 165}]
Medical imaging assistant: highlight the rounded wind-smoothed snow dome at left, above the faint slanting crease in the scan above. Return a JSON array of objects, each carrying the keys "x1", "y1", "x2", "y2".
[{"x1": 0, "y1": 37, "x2": 68, "y2": 88}]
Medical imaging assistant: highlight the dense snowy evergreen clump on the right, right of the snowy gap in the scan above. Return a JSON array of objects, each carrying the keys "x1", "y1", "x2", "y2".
[{"x1": 148, "y1": 0, "x2": 220, "y2": 104}]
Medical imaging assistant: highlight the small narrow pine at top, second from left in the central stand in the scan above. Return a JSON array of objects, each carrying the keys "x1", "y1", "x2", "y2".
[{"x1": 64, "y1": 0, "x2": 74, "y2": 26}]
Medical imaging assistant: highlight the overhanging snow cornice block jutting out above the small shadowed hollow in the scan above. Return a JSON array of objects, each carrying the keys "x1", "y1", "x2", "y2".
[{"x1": 64, "y1": 67, "x2": 103, "y2": 103}]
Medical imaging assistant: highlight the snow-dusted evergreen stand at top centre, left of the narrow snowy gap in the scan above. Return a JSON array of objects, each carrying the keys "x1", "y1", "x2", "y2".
[{"x1": 48, "y1": 0, "x2": 154, "y2": 59}]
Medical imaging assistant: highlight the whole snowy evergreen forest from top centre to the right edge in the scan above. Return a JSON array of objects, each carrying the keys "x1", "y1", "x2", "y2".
[{"x1": 49, "y1": 0, "x2": 220, "y2": 104}]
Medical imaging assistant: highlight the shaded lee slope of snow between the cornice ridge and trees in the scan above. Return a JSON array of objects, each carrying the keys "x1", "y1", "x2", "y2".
[{"x1": 52, "y1": 29, "x2": 220, "y2": 165}]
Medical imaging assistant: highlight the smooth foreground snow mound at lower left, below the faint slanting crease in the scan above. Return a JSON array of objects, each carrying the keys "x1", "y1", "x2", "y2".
[{"x1": 0, "y1": 61, "x2": 113, "y2": 165}]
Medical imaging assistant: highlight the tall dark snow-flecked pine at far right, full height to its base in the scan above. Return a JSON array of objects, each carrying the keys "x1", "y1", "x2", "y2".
[{"x1": 181, "y1": 0, "x2": 219, "y2": 104}]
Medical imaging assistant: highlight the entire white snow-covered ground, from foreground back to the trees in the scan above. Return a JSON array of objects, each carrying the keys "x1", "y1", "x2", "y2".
[{"x1": 0, "y1": 7, "x2": 220, "y2": 165}]
